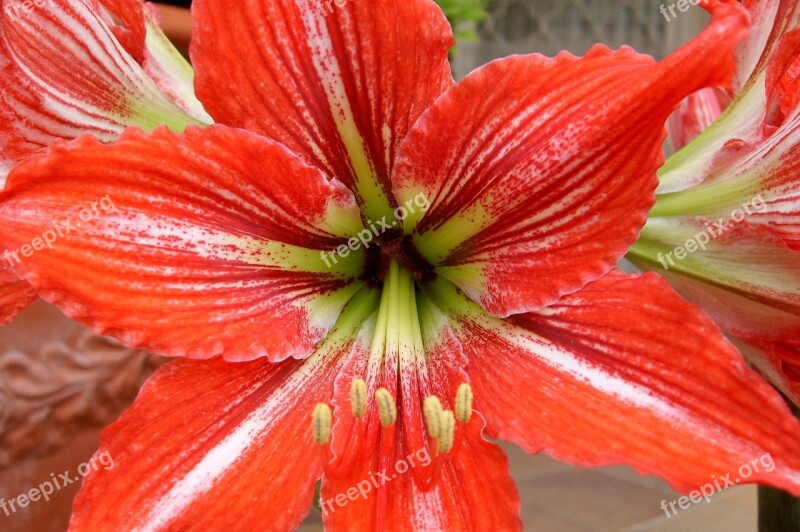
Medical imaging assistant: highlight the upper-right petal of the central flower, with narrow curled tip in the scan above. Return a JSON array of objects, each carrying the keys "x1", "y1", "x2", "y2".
[{"x1": 393, "y1": 3, "x2": 746, "y2": 316}]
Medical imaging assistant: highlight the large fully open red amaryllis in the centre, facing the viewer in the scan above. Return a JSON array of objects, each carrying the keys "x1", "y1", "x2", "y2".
[{"x1": 0, "y1": 0, "x2": 800, "y2": 530}]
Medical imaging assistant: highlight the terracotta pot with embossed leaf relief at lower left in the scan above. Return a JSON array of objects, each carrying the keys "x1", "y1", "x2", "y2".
[{"x1": 0, "y1": 301, "x2": 163, "y2": 532}]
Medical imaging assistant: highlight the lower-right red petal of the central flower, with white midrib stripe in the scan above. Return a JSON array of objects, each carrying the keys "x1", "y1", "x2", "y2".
[{"x1": 428, "y1": 271, "x2": 800, "y2": 494}]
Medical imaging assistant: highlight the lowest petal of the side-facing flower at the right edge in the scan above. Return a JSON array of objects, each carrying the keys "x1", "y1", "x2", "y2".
[{"x1": 629, "y1": 224, "x2": 800, "y2": 405}]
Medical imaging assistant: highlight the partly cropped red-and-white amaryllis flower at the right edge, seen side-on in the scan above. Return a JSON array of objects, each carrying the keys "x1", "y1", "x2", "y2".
[{"x1": 630, "y1": 0, "x2": 800, "y2": 405}]
